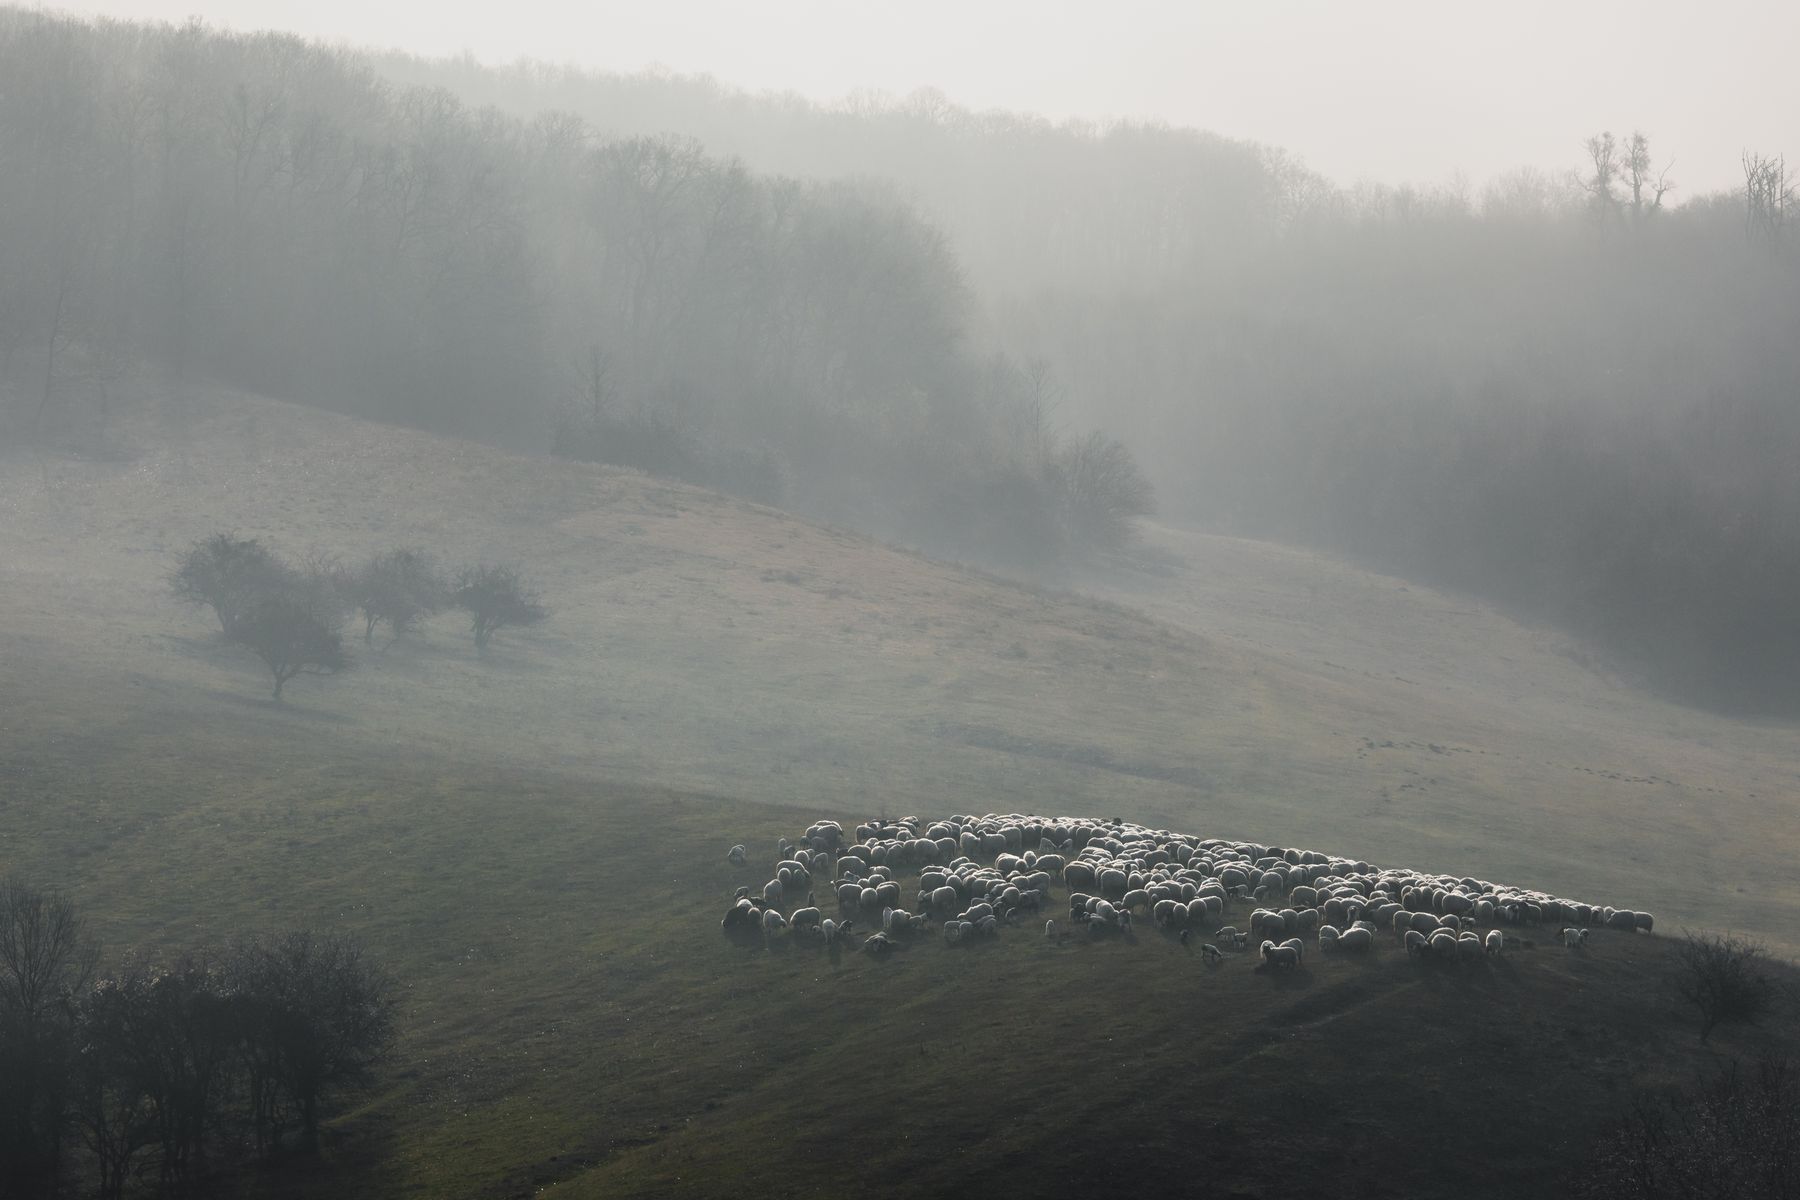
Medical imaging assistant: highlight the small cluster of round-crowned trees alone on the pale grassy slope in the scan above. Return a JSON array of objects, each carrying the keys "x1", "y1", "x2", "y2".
[{"x1": 169, "y1": 533, "x2": 549, "y2": 700}]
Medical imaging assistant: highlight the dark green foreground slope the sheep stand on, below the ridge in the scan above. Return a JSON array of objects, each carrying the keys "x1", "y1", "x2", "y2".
[{"x1": 0, "y1": 712, "x2": 1789, "y2": 1198}]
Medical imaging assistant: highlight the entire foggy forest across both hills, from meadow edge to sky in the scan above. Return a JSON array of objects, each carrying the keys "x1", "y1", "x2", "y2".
[{"x1": 0, "y1": 11, "x2": 1800, "y2": 709}]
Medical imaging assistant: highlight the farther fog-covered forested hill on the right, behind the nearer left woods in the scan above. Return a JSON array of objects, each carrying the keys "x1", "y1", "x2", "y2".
[{"x1": 380, "y1": 56, "x2": 1800, "y2": 709}]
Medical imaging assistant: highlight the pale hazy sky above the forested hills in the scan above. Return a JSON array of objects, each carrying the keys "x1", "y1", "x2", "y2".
[{"x1": 31, "y1": 0, "x2": 1800, "y2": 196}]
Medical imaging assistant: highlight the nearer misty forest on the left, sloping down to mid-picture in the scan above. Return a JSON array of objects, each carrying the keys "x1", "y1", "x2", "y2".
[{"x1": 0, "y1": 9, "x2": 1148, "y2": 563}]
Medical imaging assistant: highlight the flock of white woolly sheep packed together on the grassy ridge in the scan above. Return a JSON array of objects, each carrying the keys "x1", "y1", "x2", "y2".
[{"x1": 722, "y1": 813, "x2": 1654, "y2": 968}]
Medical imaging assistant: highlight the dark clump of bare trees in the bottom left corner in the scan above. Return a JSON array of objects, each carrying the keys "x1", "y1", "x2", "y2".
[{"x1": 0, "y1": 878, "x2": 394, "y2": 1198}]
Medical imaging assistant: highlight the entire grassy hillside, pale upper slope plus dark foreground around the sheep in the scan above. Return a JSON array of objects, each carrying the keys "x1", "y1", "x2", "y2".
[{"x1": 0, "y1": 383, "x2": 1796, "y2": 1196}]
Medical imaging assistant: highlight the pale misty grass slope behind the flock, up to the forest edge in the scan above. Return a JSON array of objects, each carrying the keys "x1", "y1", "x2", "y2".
[{"x1": 0, "y1": 379, "x2": 1800, "y2": 950}]
